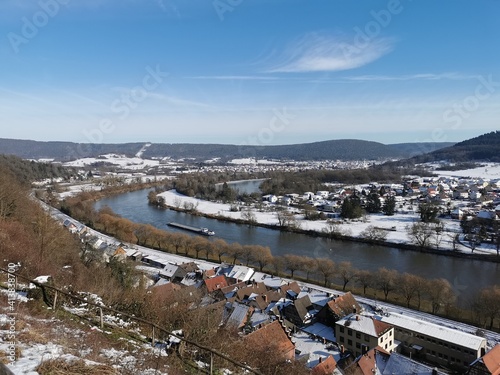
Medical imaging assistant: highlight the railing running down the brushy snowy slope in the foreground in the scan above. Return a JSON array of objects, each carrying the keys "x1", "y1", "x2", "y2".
[{"x1": 0, "y1": 267, "x2": 262, "y2": 375}]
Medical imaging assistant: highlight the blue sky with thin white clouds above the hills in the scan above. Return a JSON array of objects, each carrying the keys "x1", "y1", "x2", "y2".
[{"x1": 0, "y1": 0, "x2": 500, "y2": 145}]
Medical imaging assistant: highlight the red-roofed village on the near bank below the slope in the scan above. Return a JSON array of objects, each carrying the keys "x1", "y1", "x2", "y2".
[{"x1": 48, "y1": 194, "x2": 500, "y2": 375}]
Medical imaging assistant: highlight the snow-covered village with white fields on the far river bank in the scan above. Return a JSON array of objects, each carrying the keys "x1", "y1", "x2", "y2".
[{"x1": 153, "y1": 165, "x2": 500, "y2": 255}]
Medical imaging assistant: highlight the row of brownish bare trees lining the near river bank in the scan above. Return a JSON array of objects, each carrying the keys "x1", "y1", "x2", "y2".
[{"x1": 62, "y1": 192, "x2": 495, "y2": 330}]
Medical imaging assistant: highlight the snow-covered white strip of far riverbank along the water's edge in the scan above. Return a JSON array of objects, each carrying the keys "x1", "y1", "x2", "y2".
[{"x1": 158, "y1": 190, "x2": 500, "y2": 263}]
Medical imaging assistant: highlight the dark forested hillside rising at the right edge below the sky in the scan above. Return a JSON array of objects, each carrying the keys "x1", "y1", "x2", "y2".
[{"x1": 394, "y1": 130, "x2": 500, "y2": 163}]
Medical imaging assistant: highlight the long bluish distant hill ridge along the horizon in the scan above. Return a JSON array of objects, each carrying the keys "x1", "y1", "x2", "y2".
[{"x1": 0, "y1": 138, "x2": 452, "y2": 161}]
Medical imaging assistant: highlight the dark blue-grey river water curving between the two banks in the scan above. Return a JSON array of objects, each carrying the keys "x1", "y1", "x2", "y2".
[{"x1": 95, "y1": 185, "x2": 500, "y2": 303}]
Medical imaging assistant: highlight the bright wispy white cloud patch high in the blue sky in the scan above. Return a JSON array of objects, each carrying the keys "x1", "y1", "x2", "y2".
[{"x1": 267, "y1": 34, "x2": 394, "y2": 73}]
